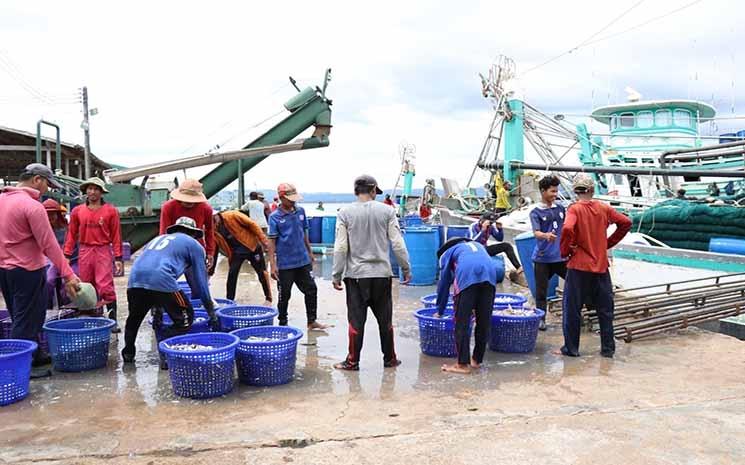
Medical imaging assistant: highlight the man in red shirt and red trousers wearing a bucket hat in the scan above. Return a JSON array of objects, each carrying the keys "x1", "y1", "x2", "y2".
[{"x1": 65, "y1": 177, "x2": 124, "y2": 333}]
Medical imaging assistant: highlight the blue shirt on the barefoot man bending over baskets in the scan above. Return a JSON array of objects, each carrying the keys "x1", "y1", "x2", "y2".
[{"x1": 437, "y1": 241, "x2": 497, "y2": 315}]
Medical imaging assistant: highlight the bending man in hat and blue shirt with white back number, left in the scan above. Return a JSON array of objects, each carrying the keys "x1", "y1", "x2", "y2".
[{"x1": 122, "y1": 216, "x2": 220, "y2": 370}]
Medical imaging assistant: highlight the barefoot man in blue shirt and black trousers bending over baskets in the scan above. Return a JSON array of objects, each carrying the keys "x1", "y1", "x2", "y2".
[{"x1": 436, "y1": 237, "x2": 497, "y2": 374}]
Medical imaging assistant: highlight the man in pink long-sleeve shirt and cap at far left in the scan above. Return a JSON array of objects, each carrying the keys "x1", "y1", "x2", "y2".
[{"x1": 0, "y1": 163, "x2": 80, "y2": 377}]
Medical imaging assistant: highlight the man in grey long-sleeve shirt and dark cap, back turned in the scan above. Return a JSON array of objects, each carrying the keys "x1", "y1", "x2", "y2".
[{"x1": 331, "y1": 175, "x2": 411, "y2": 371}]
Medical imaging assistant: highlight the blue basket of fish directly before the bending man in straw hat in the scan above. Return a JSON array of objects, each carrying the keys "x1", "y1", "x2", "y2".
[{"x1": 158, "y1": 333, "x2": 238, "y2": 399}]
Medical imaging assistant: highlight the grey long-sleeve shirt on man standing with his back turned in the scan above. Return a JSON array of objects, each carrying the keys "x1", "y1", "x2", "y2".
[{"x1": 334, "y1": 201, "x2": 408, "y2": 279}]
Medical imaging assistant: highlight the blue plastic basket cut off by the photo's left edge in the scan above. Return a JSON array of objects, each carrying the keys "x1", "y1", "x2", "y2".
[{"x1": 0, "y1": 339, "x2": 37, "y2": 405}]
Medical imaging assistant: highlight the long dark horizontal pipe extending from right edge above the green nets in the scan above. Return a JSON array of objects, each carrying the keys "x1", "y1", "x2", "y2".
[{"x1": 479, "y1": 160, "x2": 745, "y2": 178}]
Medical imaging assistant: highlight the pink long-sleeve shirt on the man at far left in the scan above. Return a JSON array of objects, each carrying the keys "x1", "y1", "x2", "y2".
[{"x1": 0, "y1": 187, "x2": 73, "y2": 279}]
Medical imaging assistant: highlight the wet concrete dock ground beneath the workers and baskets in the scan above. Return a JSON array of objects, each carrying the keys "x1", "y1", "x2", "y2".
[{"x1": 0, "y1": 256, "x2": 745, "y2": 464}]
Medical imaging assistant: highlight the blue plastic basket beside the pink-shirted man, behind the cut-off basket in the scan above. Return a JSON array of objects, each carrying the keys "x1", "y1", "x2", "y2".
[{"x1": 44, "y1": 318, "x2": 116, "y2": 371}]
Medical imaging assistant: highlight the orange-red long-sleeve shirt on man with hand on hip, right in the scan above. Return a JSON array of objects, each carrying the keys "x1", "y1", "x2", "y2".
[{"x1": 560, "y1": 200, "x2": 631, "y2": 273}]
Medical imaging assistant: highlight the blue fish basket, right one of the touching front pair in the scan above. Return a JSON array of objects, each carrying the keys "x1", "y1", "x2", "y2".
[{"x1": 230, "y1": 326, "x2": 303, "y2": 386}]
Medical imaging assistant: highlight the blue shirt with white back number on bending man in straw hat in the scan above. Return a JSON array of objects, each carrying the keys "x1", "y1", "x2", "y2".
[{"x1": 127, "y1": 233, "x2": 212, "y2": 306}]
